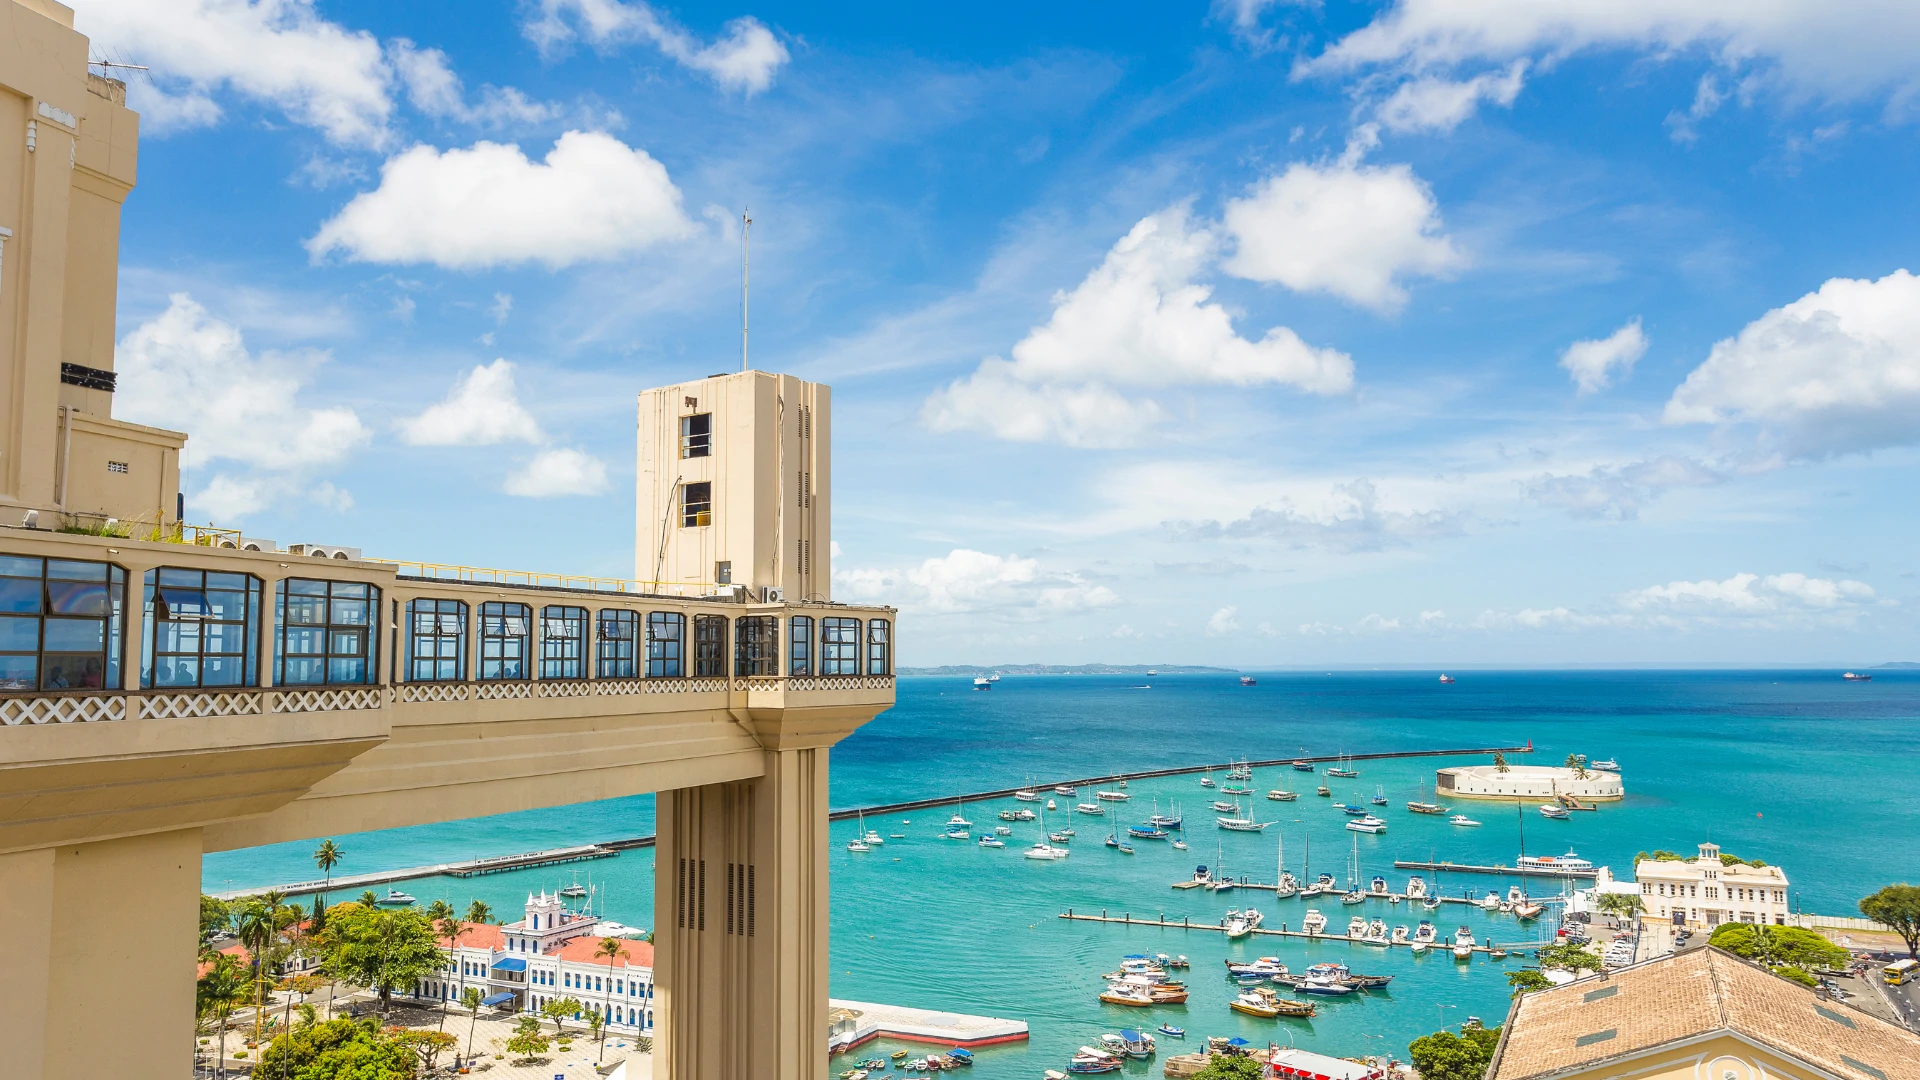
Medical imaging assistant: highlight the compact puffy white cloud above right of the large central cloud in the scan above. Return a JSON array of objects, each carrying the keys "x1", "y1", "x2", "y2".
[{"x1": 1225, "y1": 146, "x2": 1465, "y2": 311}]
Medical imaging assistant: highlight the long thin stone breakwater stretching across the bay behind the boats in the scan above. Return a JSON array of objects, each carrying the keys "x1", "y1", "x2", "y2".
[{"x1": 207, "y1": 744, "x2": 1534, "y2": 899}]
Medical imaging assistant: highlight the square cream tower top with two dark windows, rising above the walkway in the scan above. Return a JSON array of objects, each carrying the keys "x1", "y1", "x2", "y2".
[{"x1": 634, "y1": 371, "x2": 833, "y2": 601}]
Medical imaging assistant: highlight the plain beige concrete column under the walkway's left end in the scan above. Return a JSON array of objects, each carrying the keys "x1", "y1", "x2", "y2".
[{"x1": 0, "y1": 828, "x2": 200, "y2": 1080}]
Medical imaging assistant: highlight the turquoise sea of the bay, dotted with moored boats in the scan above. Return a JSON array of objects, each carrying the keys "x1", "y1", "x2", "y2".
[{"x1": 204, "y1": 671, "x2": 1920, "y2": 1080}]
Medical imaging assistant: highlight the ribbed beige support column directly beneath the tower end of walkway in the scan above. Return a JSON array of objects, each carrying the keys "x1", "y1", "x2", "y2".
[{"x1": 653, "y1": 748, "x2": 829, "y2": 1080}]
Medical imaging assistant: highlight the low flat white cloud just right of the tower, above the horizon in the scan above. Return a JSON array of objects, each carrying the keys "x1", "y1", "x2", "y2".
[{"x1": 833, "y1": 548, "x2": 1119, "y2": 621}]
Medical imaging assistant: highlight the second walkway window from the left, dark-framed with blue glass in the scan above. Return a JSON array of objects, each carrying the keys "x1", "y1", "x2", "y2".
[{"x1": 140, "y1": 567, "x2": 261, "y2": 688}]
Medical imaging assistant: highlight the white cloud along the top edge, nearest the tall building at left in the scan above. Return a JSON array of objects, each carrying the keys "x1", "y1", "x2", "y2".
[{"x1": 73, "y1": 0, "x2": 394, "y2": 146}]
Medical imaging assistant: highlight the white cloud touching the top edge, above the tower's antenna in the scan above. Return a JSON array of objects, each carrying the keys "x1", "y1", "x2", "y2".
[{"x1": 522, "y1": 0, "x2": 789, "y2": 94}]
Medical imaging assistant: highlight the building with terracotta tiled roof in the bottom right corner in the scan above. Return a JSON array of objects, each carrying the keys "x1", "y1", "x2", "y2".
[{"x1": 1486, "y1": 947, "x2": 1920, "y2": 1080}]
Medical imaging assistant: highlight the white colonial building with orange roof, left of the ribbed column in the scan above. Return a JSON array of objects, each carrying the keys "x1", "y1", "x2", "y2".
[{"x1": 413, "y1": 892, "x2": 653, "y2": 1036}]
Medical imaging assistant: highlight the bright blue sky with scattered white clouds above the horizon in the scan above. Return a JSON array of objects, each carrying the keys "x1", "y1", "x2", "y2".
[{"x1": 75, "y1": 0, "x2": 1920, "y2": 665}]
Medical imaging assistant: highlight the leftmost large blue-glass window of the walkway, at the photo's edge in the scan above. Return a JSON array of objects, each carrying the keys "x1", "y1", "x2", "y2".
[{"x1": 0, "y1": 555, "x2": 127, "y2": 690}]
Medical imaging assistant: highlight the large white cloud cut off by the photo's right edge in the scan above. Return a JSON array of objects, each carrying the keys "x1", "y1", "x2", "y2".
[{"x1": 1665, "y1": 269, "x2": 1920, "y2": 455}]
